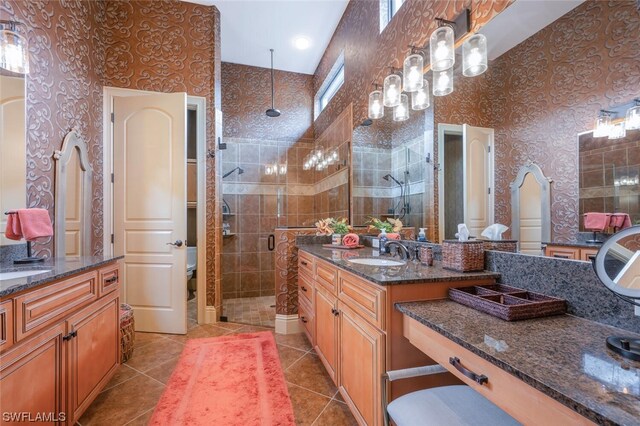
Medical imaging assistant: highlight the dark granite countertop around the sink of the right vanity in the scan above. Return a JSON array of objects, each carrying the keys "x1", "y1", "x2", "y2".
[{"x1": 298, "y1": 244, "x2": 500, "y2": 285}]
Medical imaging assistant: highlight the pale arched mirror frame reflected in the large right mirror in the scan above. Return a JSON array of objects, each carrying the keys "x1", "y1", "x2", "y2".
[{"x1": 509, "y1": 161, "x2": 553, "y2": 248}]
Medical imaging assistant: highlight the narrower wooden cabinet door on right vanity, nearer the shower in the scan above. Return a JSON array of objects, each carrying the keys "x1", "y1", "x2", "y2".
[{"x1": 314, "y1": 286, "x2": 338, "y2": 384}]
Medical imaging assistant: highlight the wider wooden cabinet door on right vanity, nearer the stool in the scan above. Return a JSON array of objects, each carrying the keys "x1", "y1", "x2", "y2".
[{"x1": 338, "y1": 302, "x2": 384, "y2": 425}]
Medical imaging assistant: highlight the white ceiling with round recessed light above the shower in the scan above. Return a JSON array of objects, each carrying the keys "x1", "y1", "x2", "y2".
[{"x1": 189, "y1": 0, "x2": 349, "y2": 74}]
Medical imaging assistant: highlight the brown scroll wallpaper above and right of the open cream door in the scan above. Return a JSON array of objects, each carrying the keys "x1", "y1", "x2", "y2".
[{"x1": 104, "y1": 1, "x2": 221, "y2": 306}]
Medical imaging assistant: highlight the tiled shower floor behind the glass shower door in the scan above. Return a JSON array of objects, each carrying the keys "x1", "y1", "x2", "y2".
[{"x1": 222, "y1": 296, "x2": 276, "y2": 327}]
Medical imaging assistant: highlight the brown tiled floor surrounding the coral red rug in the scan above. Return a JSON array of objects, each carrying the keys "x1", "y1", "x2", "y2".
[{"x1": 79, "y1": 320, "x2": 356, "y2": 426}]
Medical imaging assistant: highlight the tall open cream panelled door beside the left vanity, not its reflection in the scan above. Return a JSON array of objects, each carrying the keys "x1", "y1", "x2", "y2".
[{"x1": 113, "y1": 93, "x2": 187, "y2": 334}]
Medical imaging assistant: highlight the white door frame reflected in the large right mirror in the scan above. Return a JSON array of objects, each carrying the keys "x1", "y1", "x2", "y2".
[{"x1": 438, "y1": 123, "x2": 496, "y2": 243}]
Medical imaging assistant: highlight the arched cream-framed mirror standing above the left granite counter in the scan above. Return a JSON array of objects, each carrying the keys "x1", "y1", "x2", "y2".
[{"x1": 53, "y1": 129, "x2": 93, "y2": 257}]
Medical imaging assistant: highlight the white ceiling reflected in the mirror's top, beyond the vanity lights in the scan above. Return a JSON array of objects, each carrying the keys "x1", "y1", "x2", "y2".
[{"x1": 480, "y1": 0, "x2": 584, "y2": 60}]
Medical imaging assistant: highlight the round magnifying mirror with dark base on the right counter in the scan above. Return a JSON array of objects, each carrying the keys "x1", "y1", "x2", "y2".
[{"x1": 593, "y1": 226, "x2": 640, "y2": 361}]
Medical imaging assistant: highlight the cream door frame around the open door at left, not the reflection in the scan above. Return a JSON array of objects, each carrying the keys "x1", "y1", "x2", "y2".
[{"x1": 102, "y1": 86, "x2": 207, "y2": 324}]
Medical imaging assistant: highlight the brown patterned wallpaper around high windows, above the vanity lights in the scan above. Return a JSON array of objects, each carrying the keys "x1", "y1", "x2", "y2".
[{"x1": 314, "y1": 0, "x2": 511, "y2": 134}]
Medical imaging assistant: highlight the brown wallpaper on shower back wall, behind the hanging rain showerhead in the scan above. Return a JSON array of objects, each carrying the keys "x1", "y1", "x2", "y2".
[{"x1": 222, "y1": 62, "x2": 313, "y2": 142}]
